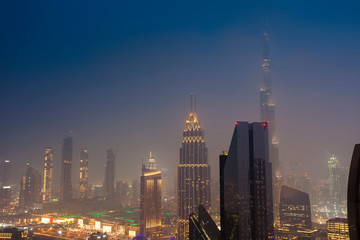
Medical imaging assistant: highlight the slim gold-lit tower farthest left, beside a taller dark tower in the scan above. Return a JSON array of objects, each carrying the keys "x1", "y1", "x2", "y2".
[{"x1": 42, "y1": 148, "x2": 54, "y2": 202}]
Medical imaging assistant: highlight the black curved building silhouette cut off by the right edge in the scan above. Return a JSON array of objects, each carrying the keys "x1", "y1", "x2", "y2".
[{"x1": 348, "y1": 144, "x2": 360, "y2": 240}]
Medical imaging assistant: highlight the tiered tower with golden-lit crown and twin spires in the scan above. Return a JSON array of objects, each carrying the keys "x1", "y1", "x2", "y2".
[{"x1": 178, "y1": 95, "x2": 210, "y2": 239}]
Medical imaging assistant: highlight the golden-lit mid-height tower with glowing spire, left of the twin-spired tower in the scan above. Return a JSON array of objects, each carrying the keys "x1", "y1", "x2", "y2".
[{"x1": 140, "y1": 153, "x2": 161, "y2": 237}]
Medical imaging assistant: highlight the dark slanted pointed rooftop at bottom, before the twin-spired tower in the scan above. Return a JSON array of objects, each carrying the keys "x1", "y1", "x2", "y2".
[{"x1": 189, "y1": 205, "x2": 221, "y2": 240}]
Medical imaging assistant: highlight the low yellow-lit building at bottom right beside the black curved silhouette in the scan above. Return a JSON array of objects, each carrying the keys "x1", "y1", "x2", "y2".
[{"x1": 326, "y1": 218, "x2": 350, "y2": 240}]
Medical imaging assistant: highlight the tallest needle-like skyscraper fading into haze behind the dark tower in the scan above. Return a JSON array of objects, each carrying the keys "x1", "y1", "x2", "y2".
[{"x1": 260, "y1": 23, "x2": 282, "y2": 218}]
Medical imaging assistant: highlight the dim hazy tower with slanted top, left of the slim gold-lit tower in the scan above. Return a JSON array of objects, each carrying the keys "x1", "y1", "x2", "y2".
[{"x1": 19, "y1": 164, "x2": 41, "y2": 209}]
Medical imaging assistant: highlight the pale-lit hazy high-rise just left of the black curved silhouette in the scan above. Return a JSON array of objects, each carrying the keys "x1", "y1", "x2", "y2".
[{"x1": 328, "y1": 154, "x2": 342, "y2": 216}]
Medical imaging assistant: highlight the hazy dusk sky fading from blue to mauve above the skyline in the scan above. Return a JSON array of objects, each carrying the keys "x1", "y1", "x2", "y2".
[{"x1": 0, "y1": 0, "x2": 360, "y2": 190}]
